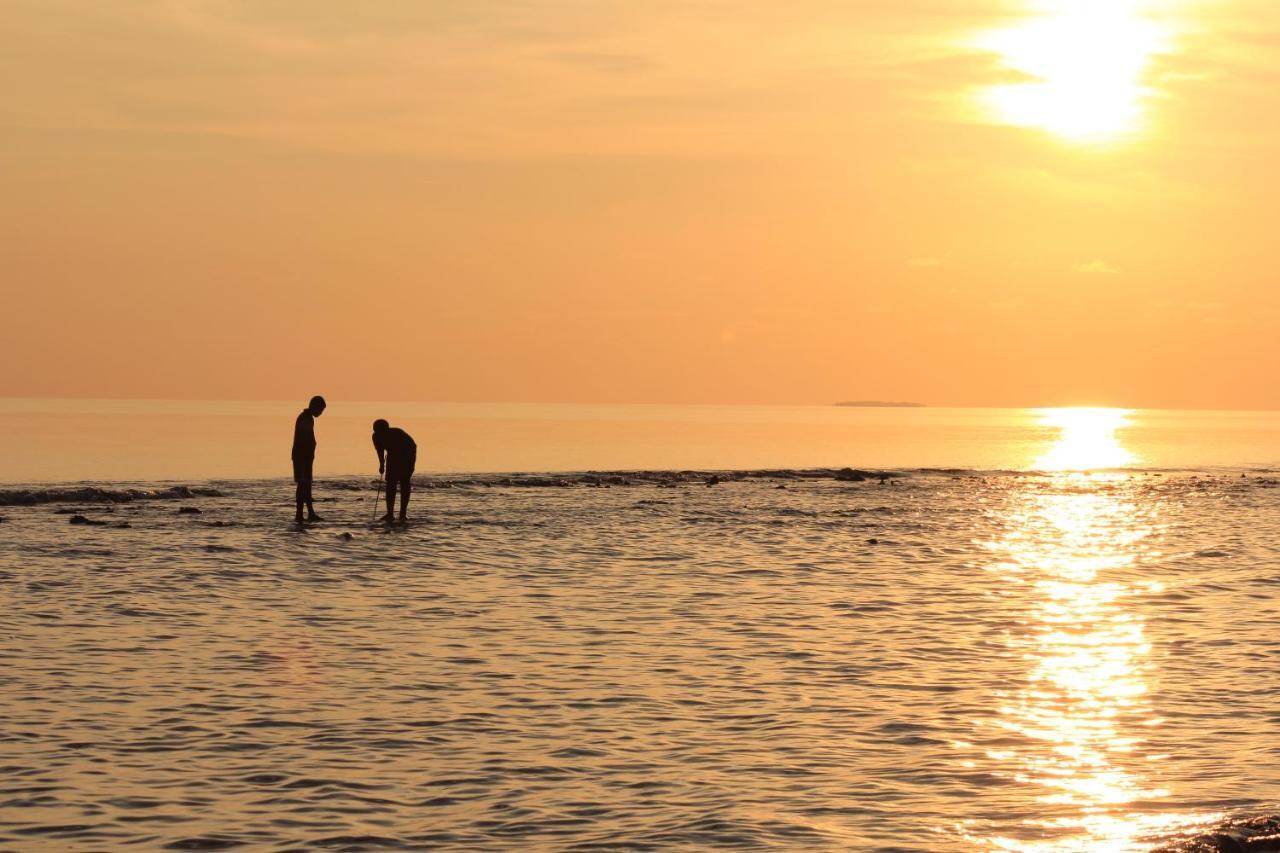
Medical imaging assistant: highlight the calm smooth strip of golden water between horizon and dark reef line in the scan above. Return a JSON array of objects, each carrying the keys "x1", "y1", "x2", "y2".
[{"x1": 0, "y1": 398, "x2": 1280, "y2": 483}]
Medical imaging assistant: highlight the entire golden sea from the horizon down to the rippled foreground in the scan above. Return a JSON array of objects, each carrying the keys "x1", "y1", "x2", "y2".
[{"x1": 0, "y1": 400, "x2": 1280, "y2": 853}]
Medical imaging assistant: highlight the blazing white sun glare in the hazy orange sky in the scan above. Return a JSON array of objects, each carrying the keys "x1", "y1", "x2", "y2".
[{"x1": 978, "y1": 0, "x2": 1169, "y2": 142}]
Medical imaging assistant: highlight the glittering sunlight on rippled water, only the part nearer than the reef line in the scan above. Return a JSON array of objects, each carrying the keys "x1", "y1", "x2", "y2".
[{"x1": 996, "y1": 481, "x2": 1165, "y2": 850}]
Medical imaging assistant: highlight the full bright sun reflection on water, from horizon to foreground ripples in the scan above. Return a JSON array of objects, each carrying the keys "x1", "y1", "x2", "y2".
[{"x1": 983, "y1": 410, "x2": 1204, "y2": 853}]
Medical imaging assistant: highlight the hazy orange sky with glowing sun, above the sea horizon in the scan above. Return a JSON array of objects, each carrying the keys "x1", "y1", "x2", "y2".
[{"x1": 0, "y1": 0, "x2": 1280, "y2": 409}]
